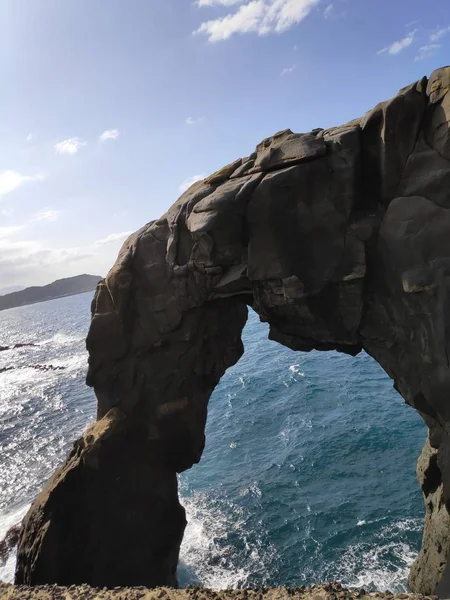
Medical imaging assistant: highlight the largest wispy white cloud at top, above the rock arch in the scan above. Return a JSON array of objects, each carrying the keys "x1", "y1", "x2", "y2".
[{"x1": 195, "y1": 0, "x2": 321, "y2": 42}]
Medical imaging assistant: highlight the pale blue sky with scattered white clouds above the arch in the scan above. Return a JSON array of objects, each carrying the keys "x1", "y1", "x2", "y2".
[{"x1": 0, "y1": 0, "x2": 450, "y2": 293}]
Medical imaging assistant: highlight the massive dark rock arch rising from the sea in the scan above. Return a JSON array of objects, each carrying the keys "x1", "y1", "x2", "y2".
[{"x1": 16, "y1": 68, "x2": 450, "y2": 595}]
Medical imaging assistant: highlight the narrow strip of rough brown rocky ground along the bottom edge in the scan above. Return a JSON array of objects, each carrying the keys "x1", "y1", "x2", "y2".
[{"x1": 0, "y1": 582, "x2": 437, "y2": 600}]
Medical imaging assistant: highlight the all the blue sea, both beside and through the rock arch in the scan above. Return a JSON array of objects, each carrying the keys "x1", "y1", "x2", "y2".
[{"x1": 0, "y1": 293, "x2": 426, "y2": 592}]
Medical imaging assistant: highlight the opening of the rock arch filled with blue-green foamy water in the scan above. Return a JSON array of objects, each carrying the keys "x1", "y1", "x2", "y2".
[{"x1": 178, "y1": 311, "x2": 426, "y2": 592}]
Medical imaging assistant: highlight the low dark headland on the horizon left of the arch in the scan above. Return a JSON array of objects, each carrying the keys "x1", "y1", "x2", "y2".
[{"x1": 0, "y1": 275, "x2": 102, "y2": 310}]
